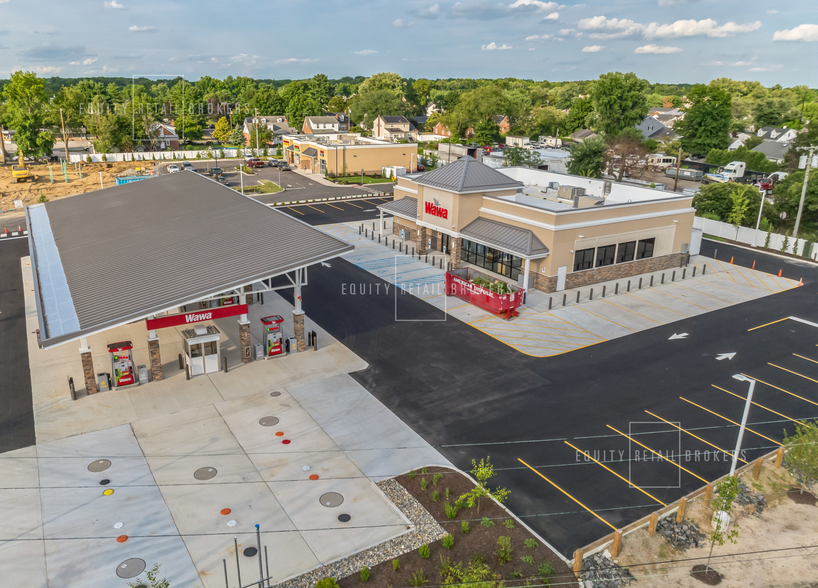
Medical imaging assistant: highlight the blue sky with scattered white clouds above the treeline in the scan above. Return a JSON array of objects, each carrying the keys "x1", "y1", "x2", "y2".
[{"x1": 0, "y1": 0, "x2": 818, "y2": 87}]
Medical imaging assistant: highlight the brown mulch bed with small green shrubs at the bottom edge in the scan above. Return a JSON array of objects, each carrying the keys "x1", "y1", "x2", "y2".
[{"x1": 339, "y1": 467, "x2": 576, "y2": 588}]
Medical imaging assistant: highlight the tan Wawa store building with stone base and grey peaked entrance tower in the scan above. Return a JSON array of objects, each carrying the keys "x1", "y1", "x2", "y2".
[{"x1": 379, "y1": 156, "x2": 695, "y2": 292}]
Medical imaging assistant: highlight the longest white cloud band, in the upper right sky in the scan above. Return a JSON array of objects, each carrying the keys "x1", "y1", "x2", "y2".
[{"x1": 577, "y1": 16, "x2": 761, "y2": 39}]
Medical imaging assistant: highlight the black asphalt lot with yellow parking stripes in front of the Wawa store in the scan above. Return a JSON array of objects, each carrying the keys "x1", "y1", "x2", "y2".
[{"x1": 280, "y1": 247, "x2": 818, "y2": 557}]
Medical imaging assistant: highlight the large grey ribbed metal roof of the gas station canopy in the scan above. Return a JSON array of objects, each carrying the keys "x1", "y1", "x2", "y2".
[{"x1": 26, "y1": 171, "x2": 353, "y2": 348}]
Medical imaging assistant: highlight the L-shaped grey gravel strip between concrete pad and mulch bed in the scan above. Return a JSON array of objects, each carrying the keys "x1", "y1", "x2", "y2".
[{"x1": 277, "y1": 479, "x2": 446, "y2": 588}]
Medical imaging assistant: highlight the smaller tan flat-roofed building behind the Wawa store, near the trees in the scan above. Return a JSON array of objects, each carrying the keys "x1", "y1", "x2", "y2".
[{"x1": 282, "y1": 133, "x2": 417, "y2": 175}]
